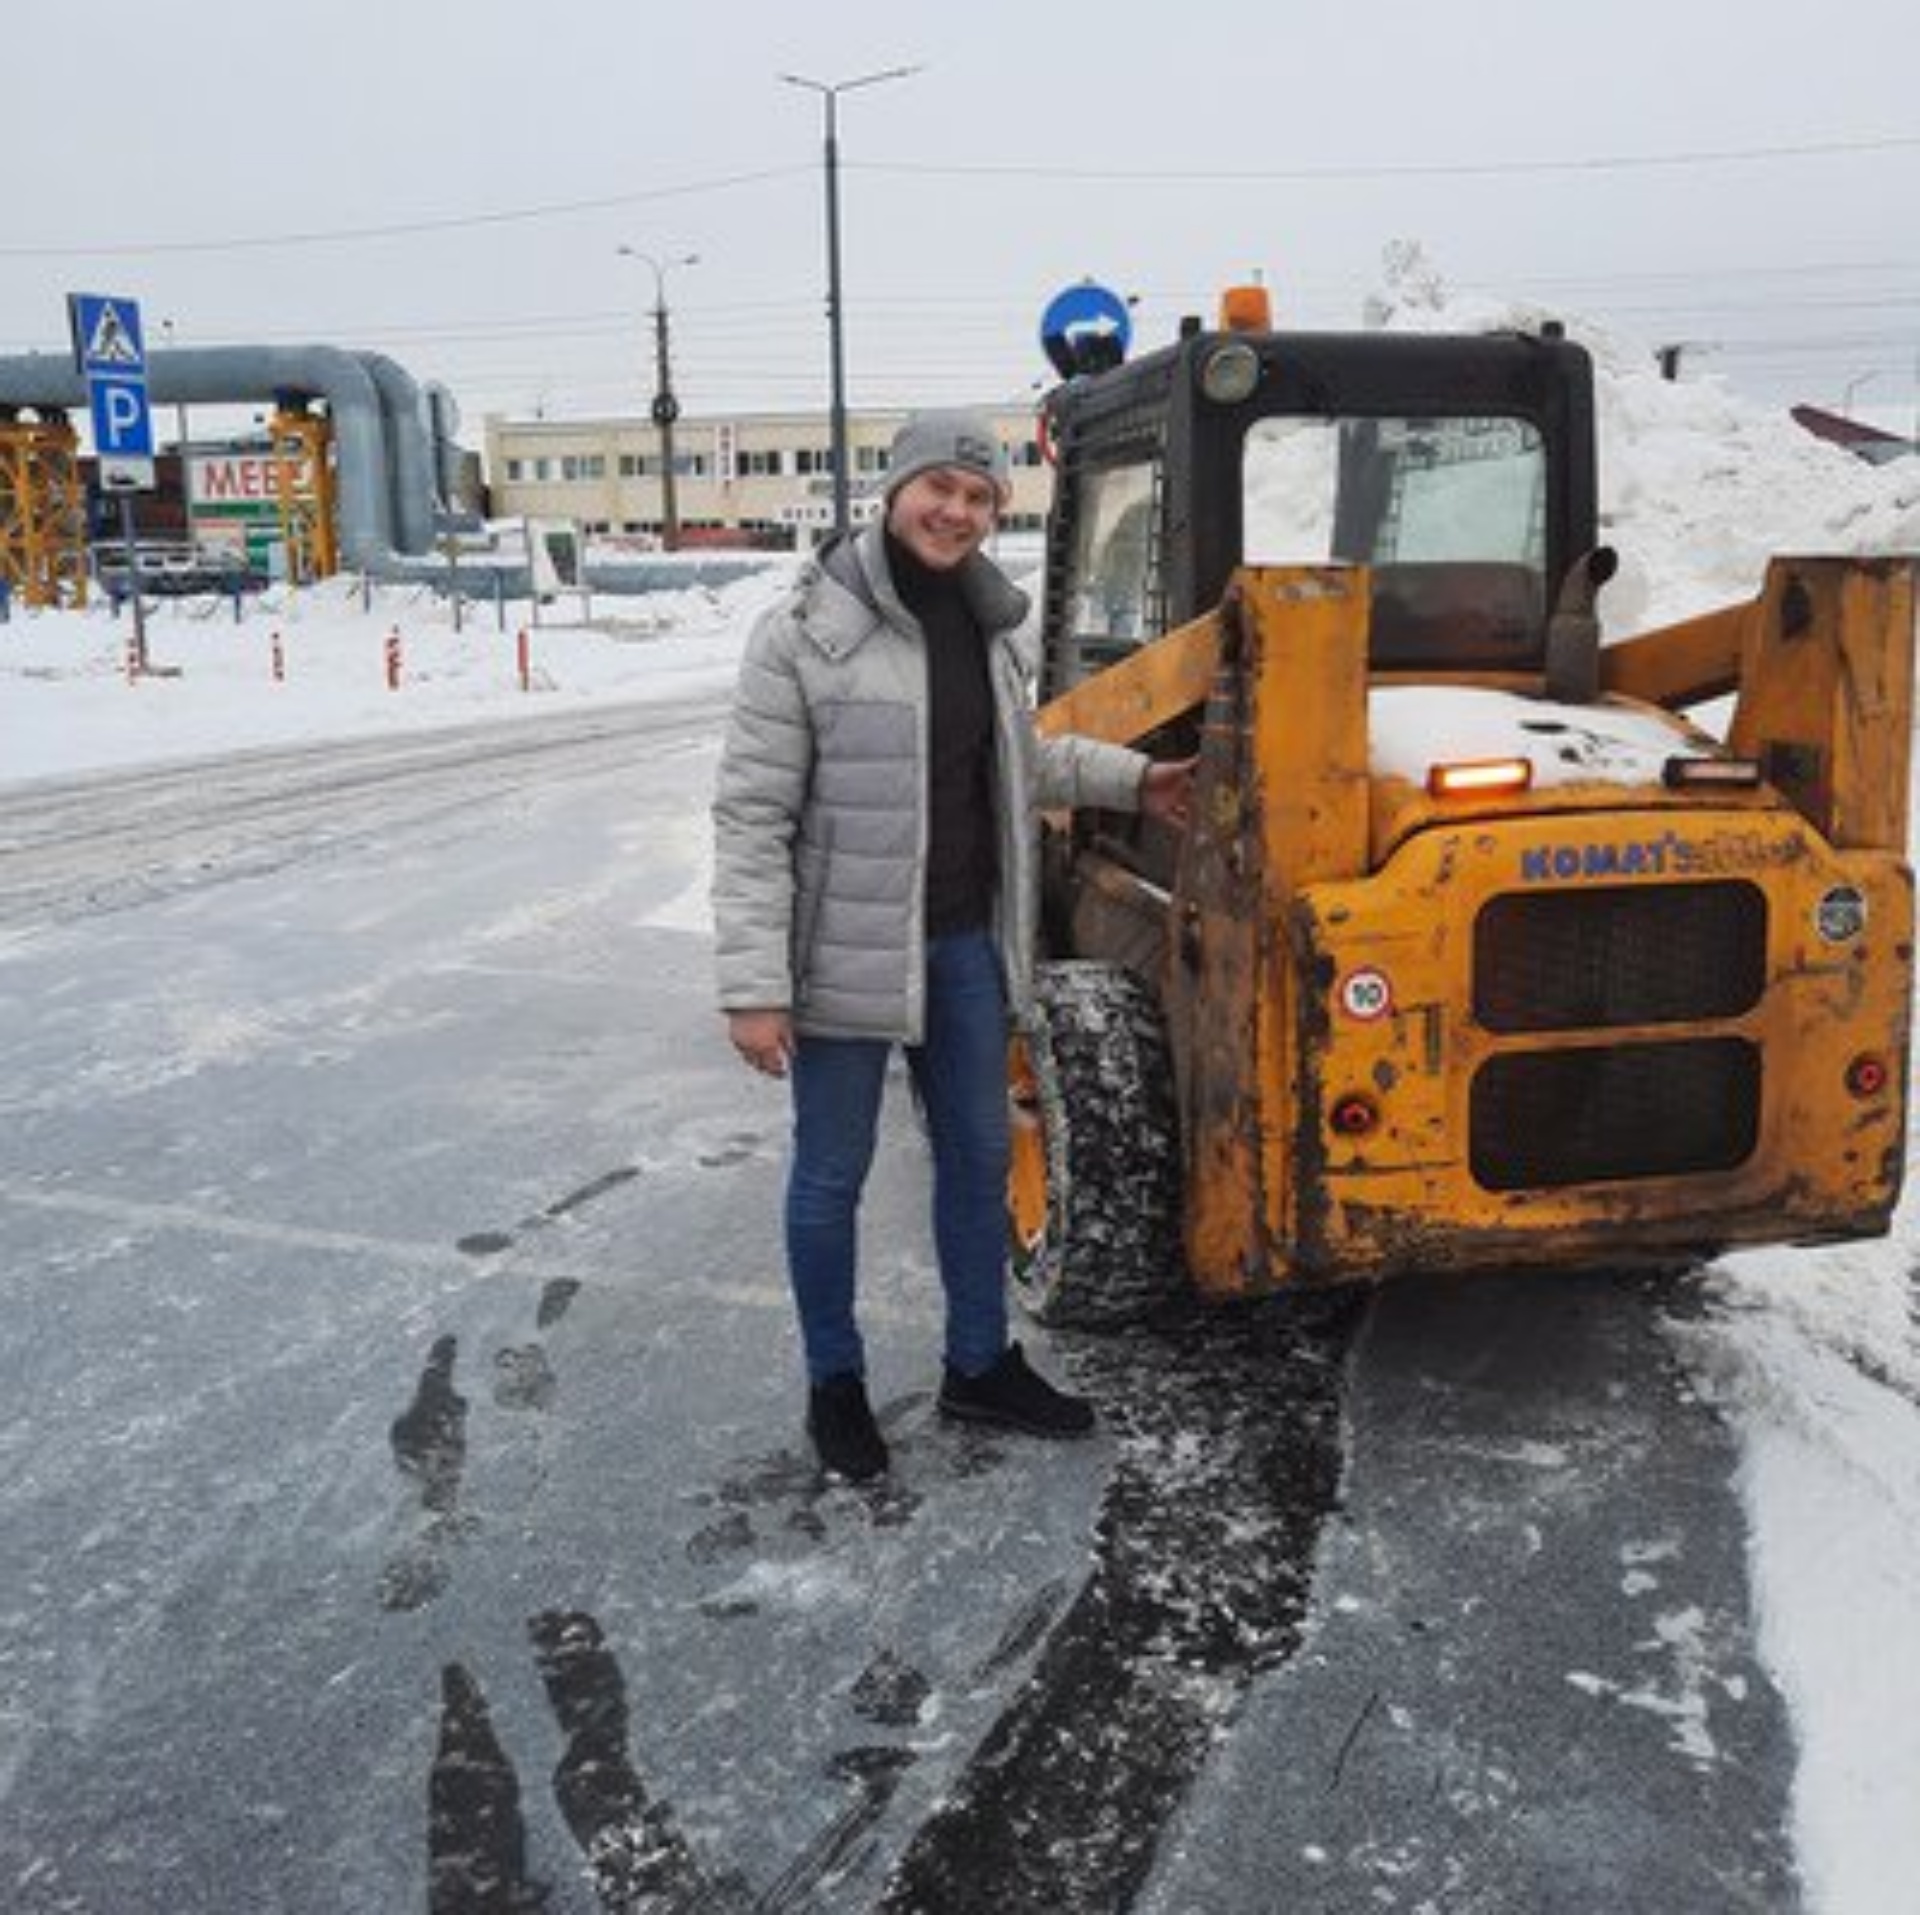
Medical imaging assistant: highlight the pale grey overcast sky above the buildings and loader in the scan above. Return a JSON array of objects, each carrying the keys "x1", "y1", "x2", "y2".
[{"x1": 0, "y1": 0, "x2": 1920, "y2": 438}]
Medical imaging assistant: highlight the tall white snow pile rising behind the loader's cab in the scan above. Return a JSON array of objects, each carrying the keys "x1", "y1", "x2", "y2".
[{"x1": 1367, "y1": 246, "x2": 1920, "y2": 636}]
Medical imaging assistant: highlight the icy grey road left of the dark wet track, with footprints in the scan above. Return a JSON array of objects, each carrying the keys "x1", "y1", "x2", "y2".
[{"x1": 0, "y1": 705, "x2": 1144, "y2": 1915}]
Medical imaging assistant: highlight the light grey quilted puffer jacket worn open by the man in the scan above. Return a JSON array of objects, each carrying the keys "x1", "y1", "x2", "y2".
[{"x1": 712, "y1": 524, "x2": 1148, "y2": 1043}]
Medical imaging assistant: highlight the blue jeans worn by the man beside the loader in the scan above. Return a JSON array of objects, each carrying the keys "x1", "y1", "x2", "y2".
[{"x1": 787, "y1": 932, "x2": 1008, "y2": 1383}]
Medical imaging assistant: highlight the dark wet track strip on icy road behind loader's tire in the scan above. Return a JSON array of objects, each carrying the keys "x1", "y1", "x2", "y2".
[{"x1": 879, "y1": 1295, "x2": 1365, "y2": 1915}]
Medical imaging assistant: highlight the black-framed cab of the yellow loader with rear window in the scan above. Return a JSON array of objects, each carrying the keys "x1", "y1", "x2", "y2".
[{"x1": 1041, "y1": 330, "x2": 1596, "y2": 697}]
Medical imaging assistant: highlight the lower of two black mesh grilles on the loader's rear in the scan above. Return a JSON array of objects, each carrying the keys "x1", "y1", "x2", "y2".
[{"x1": 1471, "y1": 1037, "x2": 1761, "y2": 1191}]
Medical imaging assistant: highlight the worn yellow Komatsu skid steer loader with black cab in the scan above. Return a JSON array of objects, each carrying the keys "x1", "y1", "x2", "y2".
[{"x1": 1010, "y1": 291, "x2": 1916, "y2": 1323}]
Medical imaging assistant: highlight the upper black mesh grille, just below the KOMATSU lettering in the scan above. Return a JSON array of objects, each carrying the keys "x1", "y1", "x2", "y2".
[{"x1": 1473, "y1": 882, "x2": 1766, "y2": 1031}]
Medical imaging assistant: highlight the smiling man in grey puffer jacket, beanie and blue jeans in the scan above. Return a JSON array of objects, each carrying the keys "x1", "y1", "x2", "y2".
[{"x1": 714, "y1": 413, "x2": 1192, "y2": 1479}]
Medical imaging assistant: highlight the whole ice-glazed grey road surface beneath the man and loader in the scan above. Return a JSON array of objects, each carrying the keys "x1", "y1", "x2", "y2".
[{"x1": 0, "y1": 707, "x2": 1797, "y2": 1915}]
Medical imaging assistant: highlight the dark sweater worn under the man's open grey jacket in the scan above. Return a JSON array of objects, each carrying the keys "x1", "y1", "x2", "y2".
[{"x1": 887, "y1": 532, "x2": 998, "y2": 937}]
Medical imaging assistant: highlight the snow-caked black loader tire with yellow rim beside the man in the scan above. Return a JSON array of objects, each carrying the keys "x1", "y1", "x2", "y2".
[{"x1": 1008, "y1": 960, "x2": 1185, "y2": 1329}]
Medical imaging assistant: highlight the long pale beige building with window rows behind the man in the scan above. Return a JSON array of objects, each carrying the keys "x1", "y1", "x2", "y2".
[{"x1": 486, "y1": 407, "x2": 1052, "y2": 545}]
